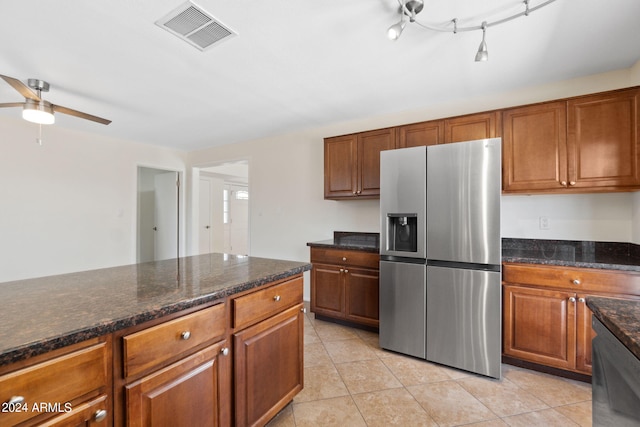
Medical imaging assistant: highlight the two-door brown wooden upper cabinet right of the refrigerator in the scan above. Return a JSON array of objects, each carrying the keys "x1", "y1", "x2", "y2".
[{"x1": 502, "y1": 88, "x2": 640, "y2": 193}]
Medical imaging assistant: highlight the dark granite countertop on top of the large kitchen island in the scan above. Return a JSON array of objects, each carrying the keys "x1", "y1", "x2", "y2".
[{"x1": 0, "y1": 254, "x2": 311, "y2": 366}]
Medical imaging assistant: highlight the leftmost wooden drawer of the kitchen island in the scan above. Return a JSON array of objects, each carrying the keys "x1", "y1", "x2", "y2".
[{"x1": 0, "y1": 342, "x2": 109, "y2": 426}]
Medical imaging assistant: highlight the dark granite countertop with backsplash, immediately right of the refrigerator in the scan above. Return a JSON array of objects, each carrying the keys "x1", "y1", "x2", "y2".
[{"x1": 502, "y1": 238, "x2": 640, "y2": 271}]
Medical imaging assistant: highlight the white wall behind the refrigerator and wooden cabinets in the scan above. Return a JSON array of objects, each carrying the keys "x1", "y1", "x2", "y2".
[{"x1": 188, "y1": 64, "x2": 640, "y2": 299}]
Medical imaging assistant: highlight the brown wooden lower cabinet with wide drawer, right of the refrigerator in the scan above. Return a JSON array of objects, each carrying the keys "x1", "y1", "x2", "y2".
[{"x1": 503, "y1": 264, "x2": 640, "y2": 375}]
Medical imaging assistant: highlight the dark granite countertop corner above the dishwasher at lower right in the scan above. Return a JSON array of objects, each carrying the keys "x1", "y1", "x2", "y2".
[{"x1": 587, "y1": 297, "x2": 640, "y2": 359}]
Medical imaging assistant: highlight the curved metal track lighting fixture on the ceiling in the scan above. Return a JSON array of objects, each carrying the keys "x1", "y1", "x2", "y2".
[{"x1": 387, "y1": 0, "x2": 556, "y2": 62}]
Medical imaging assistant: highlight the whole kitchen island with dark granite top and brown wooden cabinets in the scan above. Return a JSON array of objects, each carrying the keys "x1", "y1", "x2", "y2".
[{"x1": 0, "y1": 254, "x2": 311, "y2": 425}]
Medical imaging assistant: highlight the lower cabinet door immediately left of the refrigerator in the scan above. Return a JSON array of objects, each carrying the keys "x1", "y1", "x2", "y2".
[{"x1": 345, "y1": 267, "x2": 380, "y2": 327}]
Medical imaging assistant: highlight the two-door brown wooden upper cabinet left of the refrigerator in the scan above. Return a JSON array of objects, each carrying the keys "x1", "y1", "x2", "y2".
[{"x1": 324, "y1": 128, "x2": 396, "y2": 199}]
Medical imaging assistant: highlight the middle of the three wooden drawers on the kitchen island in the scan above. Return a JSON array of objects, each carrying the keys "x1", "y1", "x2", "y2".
[{"x1": 122, "y1": 304, "x2": 225, "y2": 377}]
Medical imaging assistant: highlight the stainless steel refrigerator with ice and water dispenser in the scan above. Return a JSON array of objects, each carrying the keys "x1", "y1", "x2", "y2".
[{"x1": 380, "y1": 138, "x2": 502, "y2": 378}]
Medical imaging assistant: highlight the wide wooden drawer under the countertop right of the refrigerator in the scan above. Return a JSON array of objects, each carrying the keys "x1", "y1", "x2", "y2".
[{"x1": 503, "y1": 264, "x2": 640, "y2": 295}]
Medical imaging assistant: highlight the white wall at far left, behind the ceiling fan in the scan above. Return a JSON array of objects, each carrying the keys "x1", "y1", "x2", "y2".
[{"x1": 0, "y1": 117, "x2": 185, "y2": 282}]
